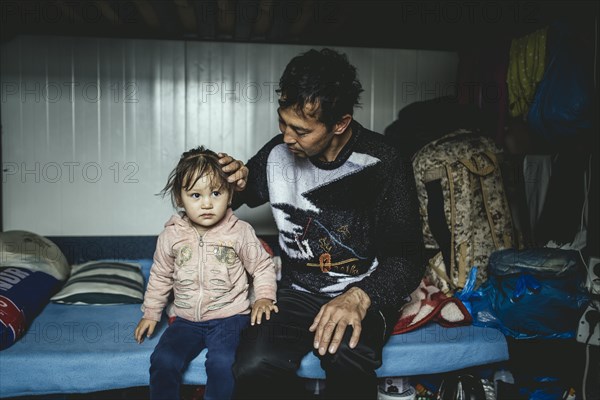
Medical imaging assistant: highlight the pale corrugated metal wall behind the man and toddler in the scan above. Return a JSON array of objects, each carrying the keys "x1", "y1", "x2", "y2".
[{"x1": 1, "y1": 36, "x2": 458, "y2": 235}]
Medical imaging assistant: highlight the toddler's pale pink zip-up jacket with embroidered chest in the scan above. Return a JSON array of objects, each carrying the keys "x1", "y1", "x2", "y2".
[{"x1": 142, "y1": 208, "x2": 277, "y2": 322}]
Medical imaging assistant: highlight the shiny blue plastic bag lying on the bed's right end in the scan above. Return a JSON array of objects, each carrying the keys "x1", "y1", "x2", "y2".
[{"x1": 468, "y1": 248, "x2": 589, "y2": 339}]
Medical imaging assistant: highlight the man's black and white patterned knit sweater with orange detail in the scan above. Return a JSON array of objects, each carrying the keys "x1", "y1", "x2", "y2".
[{"x1": 234, "y1": 121, "x2": 424, "y2": 318}]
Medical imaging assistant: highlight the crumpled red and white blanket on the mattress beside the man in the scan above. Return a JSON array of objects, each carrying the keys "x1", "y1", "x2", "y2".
[{"x1": 392, "y1": 280, "x2": 473, "y2": 335}]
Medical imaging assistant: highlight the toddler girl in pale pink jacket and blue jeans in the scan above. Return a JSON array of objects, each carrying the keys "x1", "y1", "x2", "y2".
[{"x1": 135, "y1": 147, "x2": 279, "y2": 400}]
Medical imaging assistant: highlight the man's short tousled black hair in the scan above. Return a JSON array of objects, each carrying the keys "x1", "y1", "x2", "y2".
[{"x1": 277, "y1": 49, "x2": 363, "y2": 129}]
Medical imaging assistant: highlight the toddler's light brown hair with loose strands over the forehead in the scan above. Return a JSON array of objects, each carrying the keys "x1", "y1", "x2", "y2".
[{"x1": 159, "y1": 146, "x2": 235, "y2": 207}]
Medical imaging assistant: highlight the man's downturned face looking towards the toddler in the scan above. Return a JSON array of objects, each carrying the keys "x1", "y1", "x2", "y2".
[{"x1": 277, "y1": 104, "x2": 335, "y2": 158}]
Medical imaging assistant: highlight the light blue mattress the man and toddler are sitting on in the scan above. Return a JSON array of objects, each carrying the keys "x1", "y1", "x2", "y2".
[{"x1": 0, "y1": 260, "x2": 508, "y2": 397}]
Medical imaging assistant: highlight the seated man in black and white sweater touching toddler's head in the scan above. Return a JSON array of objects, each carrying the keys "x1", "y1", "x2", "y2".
[{"x1": 221, "y1": 49, "x2": 424, "y2": 399}]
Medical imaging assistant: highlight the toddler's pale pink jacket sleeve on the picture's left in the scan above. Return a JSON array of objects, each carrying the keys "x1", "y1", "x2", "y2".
[{"x1": 142, "y1": 227, "x2": 175, "y2": 321}]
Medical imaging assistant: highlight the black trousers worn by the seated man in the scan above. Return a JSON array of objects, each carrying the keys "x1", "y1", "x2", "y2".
[{"x1": 233, "y1": 289, "x2": 391, "y2": 400}]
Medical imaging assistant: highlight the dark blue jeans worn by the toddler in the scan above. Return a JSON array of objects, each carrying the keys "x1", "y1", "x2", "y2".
[{"x1": 150, "y1": 315, "x2": 250, "y2": 400}]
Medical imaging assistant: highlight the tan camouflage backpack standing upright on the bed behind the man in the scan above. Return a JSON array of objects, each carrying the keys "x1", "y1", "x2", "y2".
[{"x1": 413, "y1": 130, "x2": 514, "y2": 293}]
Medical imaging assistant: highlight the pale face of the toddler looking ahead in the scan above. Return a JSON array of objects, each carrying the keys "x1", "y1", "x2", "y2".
[{"x1": 181, "y1": 174, "x2": 233, "y2": 233}]
